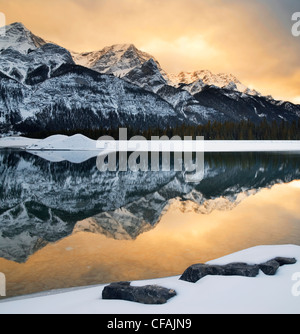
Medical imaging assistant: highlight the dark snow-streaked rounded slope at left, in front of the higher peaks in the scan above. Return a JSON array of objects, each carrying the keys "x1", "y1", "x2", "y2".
[{"x1": 0, "y1": 64, "x2": 182, "y2": 132}]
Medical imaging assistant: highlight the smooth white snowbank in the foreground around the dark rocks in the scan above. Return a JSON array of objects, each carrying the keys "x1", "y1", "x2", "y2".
[{"x1": 0, "y1": 245, "x2": 300, "y2": 314}]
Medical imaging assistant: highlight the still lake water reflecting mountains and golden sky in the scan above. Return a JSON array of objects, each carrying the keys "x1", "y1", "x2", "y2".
[{"x1": 0, "y1": 150, "x2": 300, "y2": 297}]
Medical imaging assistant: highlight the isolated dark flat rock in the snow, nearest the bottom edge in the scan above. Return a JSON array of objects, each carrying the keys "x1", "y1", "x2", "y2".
[{"x1": 102, "y1": 282, "x2": 176, "y2": 304}]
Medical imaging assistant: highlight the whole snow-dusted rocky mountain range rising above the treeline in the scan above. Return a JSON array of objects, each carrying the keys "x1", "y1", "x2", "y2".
[{"x1": 0, "y1": 23, "x2": 300, "y2": 135}]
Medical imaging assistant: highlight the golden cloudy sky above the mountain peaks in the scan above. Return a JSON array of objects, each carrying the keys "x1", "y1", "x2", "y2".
[{"x1": 0, "y1": 0, "x2": 300, "y2": 104}]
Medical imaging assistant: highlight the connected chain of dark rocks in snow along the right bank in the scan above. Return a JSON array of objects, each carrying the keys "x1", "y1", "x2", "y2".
[{"x1": 179, "y1": 257, "x2": 296, "y2": 283}]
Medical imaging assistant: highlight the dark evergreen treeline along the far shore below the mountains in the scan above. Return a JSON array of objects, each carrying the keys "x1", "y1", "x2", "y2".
[{"x1": 24, "y1": 119, "x2": 300, "y2": 140}]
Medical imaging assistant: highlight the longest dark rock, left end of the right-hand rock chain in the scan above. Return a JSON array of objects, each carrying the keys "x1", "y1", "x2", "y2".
[{"x1": 180, "y1": 262, "x2": 259, "y2": 283}]
